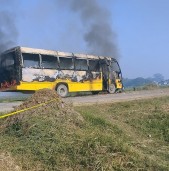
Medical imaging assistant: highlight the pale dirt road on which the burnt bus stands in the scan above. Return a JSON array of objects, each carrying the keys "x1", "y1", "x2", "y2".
[{"x1": 0, "y1": 88, "x2": 169, "y2": 112}]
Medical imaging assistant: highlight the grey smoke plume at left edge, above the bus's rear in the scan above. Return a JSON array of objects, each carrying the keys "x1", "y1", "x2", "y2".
[{"x1": 0, "y1": 0, "x2": 18, "y2": 53}]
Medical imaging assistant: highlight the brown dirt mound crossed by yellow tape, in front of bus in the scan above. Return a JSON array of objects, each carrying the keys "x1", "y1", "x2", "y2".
[{"x1": 2, "y1": 89, "x2": 83, "y2": 125}]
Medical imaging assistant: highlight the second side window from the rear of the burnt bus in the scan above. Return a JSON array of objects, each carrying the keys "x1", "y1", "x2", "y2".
[{"x1": 41, "y1": 55, "x2": 58, "y2": 69}]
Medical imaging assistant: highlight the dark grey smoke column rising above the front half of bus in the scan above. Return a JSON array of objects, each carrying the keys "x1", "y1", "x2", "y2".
[{"x1": 57, "y1": 0, "x2": 118, "y2": 59}]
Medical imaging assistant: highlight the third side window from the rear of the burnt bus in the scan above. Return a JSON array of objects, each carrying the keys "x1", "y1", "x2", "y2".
[{"x1": 59, "y1": 57, "x2": 74, "y2": 70}]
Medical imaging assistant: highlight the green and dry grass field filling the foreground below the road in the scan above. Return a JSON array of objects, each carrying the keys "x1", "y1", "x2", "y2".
[{"x1": 0, "y1": 97, "x2": 169, "y2": 171}]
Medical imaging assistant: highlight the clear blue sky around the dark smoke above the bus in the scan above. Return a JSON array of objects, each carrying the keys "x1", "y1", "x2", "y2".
[{"x1": 0, "y1": 0, "x2": 169, "y2": 79}]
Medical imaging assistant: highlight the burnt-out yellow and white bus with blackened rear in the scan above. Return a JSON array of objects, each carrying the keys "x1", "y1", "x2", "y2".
[{"x1": 0, "y1": 47, "x2": 123, "y2": 97}]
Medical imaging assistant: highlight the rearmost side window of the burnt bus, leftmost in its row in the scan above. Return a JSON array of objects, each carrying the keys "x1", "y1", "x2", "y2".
[{"x1": 22, "y1": 53, "x2": 40, "y2": 68}]
